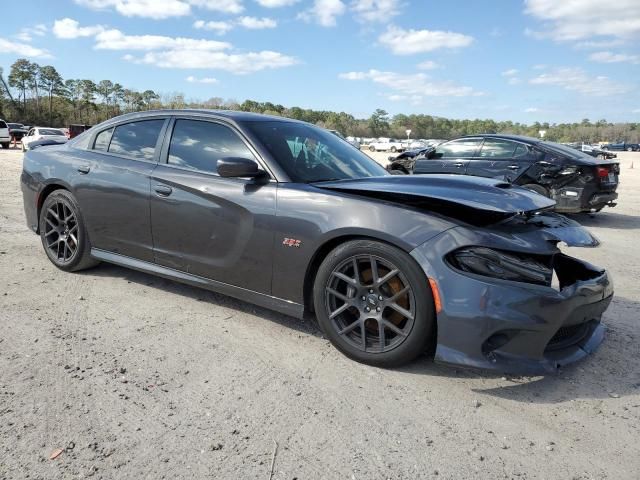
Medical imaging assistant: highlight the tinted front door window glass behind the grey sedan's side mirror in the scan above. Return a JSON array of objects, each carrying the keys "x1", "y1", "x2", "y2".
[{"x1": 168, "y1": 119, "x2": 255, "y2": 173}]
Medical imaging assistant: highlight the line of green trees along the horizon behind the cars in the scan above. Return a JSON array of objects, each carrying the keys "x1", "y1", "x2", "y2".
[{"x1": 0, "y1": 59, "x2": 640, "y2": 143}]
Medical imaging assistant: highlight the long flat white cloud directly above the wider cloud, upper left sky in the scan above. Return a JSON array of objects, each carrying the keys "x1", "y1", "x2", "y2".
[{"x1": 95, "y1": 30, "x2": 231, "y2": 52}]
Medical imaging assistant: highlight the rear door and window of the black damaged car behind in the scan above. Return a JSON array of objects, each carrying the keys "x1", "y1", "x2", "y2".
[{"x1": 467, "y1": 138, "x2": 531, "y2": 182}]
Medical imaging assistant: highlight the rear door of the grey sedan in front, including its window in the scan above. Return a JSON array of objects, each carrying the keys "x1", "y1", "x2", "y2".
[{"x1": 75, "y1": 117, "x2": 168, "y2": 262}]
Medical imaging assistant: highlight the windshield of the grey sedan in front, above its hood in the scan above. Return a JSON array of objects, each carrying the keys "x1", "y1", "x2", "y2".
[{"x1": 245, "y1": 121, "x2": 388, "y2": 183}]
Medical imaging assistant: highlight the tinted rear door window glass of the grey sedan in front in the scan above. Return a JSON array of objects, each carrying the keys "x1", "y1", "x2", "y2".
[{"x1": 109, "y1": 119, "x2": 164, "y2": 160}]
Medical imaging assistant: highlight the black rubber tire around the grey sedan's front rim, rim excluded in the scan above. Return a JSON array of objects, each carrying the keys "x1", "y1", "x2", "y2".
[{"x1": 313, "y1": 240, "x2": 435, "y2": 367}]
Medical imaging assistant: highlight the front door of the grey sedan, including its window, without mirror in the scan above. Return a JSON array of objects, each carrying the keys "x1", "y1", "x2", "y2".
[{"x1": 151, "y1": 117, "x2": 277, "y2": 293}]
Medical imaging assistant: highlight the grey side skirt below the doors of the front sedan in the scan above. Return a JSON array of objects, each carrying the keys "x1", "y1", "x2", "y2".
[{"x1": 91, "y1": 248, "x2": 304, "y2": 318}]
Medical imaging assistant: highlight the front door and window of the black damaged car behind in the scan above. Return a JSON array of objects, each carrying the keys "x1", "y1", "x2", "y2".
[{"x1": 413, "y1": 138, "x2": 482, "y2": 175}]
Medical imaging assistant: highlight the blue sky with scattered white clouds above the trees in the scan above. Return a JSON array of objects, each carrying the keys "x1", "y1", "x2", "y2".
[{"x1": 0, "y1": 0, "x2": 640, "y2": 123}]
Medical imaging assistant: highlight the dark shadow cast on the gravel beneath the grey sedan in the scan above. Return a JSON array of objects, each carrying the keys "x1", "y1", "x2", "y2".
[{"x1": 81, "y1": 263, "x2": 640, "y2": 403}]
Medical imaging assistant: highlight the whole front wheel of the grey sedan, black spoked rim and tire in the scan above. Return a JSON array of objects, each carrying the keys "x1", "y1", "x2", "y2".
[{"x1": 313, "y1": 240, "x2": 435, "y2": 367}]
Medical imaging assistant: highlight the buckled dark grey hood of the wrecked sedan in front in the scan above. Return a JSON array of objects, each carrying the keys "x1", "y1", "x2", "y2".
[{"x1": 314, "y1": 175, "x2": 556, "y2": 215}]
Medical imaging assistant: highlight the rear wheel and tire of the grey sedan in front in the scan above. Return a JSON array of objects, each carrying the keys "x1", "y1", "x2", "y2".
[{"x1": 39, "y1": 190, "x2": 100, "y2": 272}]
